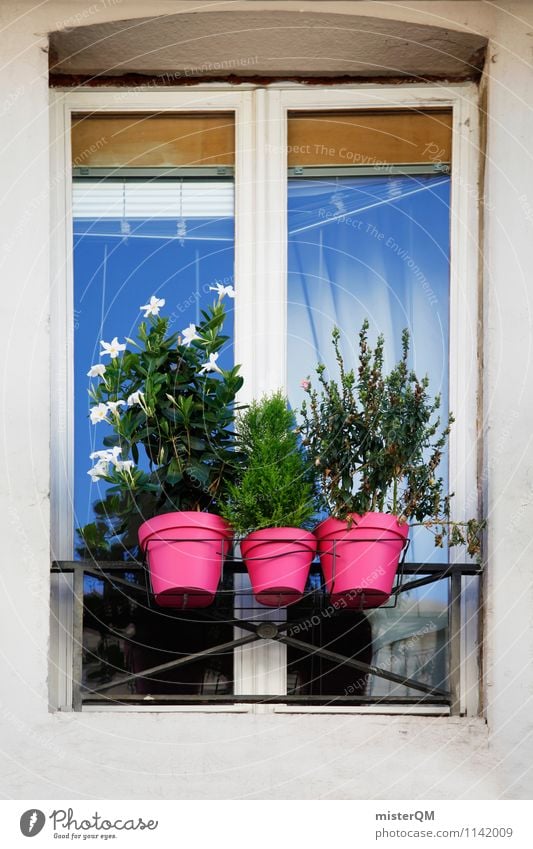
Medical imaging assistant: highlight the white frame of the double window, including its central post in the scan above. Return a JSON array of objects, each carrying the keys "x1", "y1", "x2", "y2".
[{"x1": 51, "y1": 83, "x2": 479, "y2": 715}]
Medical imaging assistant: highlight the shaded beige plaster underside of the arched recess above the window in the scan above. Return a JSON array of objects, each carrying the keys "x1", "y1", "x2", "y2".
[{"x1": 50, "y1": 7, "x2": 485, "y2": 80}]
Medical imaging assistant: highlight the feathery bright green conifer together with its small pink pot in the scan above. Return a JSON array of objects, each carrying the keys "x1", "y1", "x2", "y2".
[{"x1": 221, "y1": 392, "x2": 316, "y2": 607}]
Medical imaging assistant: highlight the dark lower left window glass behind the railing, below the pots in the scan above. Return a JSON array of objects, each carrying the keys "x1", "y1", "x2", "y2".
[{"x1": 83, "y1": 571, "x2": 234, "y2": 699}]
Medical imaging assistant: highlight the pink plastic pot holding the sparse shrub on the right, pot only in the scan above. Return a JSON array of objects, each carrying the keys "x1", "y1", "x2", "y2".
[{"x1": 315, "y1": 513, "x2": 409, "y2": 608}]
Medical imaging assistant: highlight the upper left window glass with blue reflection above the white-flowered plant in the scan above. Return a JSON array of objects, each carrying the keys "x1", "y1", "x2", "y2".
[{"x1": 72, "y1": 114, "x2": 235, "y2": 527}]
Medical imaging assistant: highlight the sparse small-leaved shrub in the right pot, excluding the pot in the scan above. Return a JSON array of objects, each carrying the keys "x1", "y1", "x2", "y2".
[{"x1": 301, "y1": 320, "x2": 484, "y2": 555}]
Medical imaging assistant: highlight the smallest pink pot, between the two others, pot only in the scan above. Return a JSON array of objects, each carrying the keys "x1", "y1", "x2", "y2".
[{"x1": 241, "y1": 528, "x2": 316, "y2": 607}]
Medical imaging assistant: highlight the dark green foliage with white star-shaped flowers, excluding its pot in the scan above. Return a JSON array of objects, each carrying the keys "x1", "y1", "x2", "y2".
[{"x1": 78, "y1": 285, "x2": 243, "y2": 559}]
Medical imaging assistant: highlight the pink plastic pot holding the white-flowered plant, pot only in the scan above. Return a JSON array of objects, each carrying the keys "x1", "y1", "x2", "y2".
[{"x1": 139, "y1": 511, "x2": 233, "y2": 608}]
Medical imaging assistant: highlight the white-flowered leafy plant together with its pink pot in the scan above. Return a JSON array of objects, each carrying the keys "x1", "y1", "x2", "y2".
[{"x1": 79, "y1": 285, "x2": 242, "y2": 607}]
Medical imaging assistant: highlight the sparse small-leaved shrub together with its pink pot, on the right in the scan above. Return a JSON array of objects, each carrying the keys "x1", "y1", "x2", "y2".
[{"x1": 301, "y1": 321, "x2": 484, "y2": 607}]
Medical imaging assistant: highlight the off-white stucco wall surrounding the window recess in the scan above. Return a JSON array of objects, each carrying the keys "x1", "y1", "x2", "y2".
[{"x1": 0, "y1": 0, "x2": 533, "y2": 799}]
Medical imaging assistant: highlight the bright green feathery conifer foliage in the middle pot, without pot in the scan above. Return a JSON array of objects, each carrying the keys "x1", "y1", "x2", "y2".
[{"x1": 220, "y1": 392, "x2": 315, "y2": 534}]
